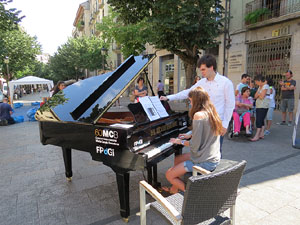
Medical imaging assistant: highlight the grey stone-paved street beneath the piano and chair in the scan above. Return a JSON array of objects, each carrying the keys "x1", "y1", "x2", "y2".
[{"x1": 0, "y1": 94, "x2": 300, "y2": 225}]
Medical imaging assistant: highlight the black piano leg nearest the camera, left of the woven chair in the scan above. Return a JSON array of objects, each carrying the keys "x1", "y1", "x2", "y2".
[{"x1": 115, "y1": 171, "x2": 130, "y2": 222}]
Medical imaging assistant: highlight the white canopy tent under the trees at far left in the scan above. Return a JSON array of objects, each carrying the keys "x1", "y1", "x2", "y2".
[{"x1": 8, "y1": 76, "x2": 54, "y2": 104}]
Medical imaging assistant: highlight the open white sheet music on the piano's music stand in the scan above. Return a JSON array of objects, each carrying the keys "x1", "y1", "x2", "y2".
[{"x1": 139, "y1": 96, "x2": 169, "y2": 121}]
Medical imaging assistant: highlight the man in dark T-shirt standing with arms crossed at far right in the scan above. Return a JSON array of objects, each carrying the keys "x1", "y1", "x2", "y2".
[{"x1": 277, "y1": 70, "x2": 296, "y2": 126}]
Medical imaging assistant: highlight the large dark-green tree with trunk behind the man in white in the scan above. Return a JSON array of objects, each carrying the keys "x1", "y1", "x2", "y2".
[{"x1": 108, "y1": 0, "x2": 224, "y2": 87}]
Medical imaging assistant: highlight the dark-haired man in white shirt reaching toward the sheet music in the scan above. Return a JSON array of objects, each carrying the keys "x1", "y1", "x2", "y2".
[{"x1": 160, "y1": 55, "x2": 235, "y2": 149}]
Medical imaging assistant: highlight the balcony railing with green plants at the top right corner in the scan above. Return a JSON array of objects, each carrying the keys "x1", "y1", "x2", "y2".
[{"x1": 245, "y1": 0, "x2": 300, "y2": 25}]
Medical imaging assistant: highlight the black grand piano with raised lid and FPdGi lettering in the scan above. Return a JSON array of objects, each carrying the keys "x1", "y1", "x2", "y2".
[{"x1": 35, "y1": 56, "x2": 189, "y2": 221}]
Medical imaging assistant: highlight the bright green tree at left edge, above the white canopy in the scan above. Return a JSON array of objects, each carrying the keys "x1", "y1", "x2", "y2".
[{"x1": 0, "y1": 29, "x2": 41, "y2": 78}]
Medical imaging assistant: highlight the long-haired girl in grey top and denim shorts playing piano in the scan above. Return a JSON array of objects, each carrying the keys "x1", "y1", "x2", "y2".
[{"x1": 162, "y1": 87, "x2": 222, "y2": 194}]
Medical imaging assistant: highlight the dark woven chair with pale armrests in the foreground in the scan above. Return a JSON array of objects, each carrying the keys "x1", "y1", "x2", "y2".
[{"x1": 140, "y1": 161, "x2": 246, "y2": 225}]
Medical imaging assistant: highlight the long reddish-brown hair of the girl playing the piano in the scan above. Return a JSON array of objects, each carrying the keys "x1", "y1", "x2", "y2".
[{"x1": 189, "y1": 87, "x2": 223, "y2": 136}]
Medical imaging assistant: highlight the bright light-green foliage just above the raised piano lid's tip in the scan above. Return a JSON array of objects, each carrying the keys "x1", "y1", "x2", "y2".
[{"x1": 97, "y1": 10, "x2": 148, "y2": 58}]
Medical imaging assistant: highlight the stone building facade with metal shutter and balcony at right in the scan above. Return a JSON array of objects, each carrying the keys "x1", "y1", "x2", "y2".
[{"x1": 225, "y1": 0, "x2": 300, "y2": 103}]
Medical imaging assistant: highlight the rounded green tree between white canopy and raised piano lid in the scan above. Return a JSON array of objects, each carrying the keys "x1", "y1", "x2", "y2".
[{"x1": 49, "y1": 37, "x2": 105, "y2": 80}]
